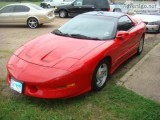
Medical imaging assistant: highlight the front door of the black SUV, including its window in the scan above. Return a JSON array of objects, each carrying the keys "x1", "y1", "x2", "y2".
[{"x1": 69, "y1": 0, "x2": 94, "y2": 15}]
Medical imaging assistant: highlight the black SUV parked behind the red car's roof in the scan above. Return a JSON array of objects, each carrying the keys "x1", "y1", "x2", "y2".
[{"x1": 55, "y1": 0, "x2": 110, "y2": 18}]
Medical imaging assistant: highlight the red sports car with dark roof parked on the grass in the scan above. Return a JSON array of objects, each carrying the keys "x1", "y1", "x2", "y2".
[{"x1": 7, "y1": 11, "x2": 146, "y2": 98}]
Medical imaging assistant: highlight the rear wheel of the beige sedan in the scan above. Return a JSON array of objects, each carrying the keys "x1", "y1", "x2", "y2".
[{"x1": 27, "y1": 18, "x2": 39, "y2": 29}]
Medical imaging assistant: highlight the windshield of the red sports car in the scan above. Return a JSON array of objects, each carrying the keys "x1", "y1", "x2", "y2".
[{"x1": 54, "y1": 15, "x2": 116, "y2": 40}]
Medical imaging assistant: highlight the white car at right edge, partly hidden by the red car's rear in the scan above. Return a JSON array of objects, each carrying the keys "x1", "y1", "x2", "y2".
[{"x1": 133, "y1": 14, "x2": 160, "y2": 33}]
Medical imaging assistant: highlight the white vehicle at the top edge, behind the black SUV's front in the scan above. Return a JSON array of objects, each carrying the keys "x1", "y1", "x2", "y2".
[{"x1": 40, "y1": 0, "x2": 74, "y2": 8}]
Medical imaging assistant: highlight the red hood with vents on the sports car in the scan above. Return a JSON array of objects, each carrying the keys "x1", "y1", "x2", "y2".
[{"x1": 14, "y1": 33, "x2": 105, "y2": 67}]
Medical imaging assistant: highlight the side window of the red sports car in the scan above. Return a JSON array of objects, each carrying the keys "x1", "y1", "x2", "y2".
[{"x1": 118, "y1": 16, "x2": 133, "y2": 31}]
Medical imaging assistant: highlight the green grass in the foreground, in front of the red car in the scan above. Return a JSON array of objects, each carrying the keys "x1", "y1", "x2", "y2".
[{"x1": 0, "y1": 81, "x2": 160, "y2": 120}]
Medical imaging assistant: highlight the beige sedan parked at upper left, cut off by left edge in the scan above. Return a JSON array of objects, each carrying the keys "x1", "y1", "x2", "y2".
[{"x1": 0, "y1": 3, "x2": 55, "y2": 28}]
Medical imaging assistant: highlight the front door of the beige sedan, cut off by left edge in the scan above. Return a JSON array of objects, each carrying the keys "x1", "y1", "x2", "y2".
[{"x1": 0, "y1": 6, "x2": 14, "y2": 23}]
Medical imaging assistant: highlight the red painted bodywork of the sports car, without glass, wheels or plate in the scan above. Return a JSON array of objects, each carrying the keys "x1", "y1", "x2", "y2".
[{"x1": 7, "y1": 15, "x2": 145, "y2": 98}]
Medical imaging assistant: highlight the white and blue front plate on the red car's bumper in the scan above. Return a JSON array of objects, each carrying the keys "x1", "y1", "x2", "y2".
[{"x1": 10, "y1": 78, "x2": 23, "y2": 93}]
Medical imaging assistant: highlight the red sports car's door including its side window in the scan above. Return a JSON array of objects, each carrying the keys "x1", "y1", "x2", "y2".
[{"x1": 114, "y1": 16, "x2": 138, "y2": 66}]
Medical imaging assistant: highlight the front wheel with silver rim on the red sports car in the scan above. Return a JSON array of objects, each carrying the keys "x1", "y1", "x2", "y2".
[{"x1": 91, "y1": 59, "x2": 109, "y2": 91}]
